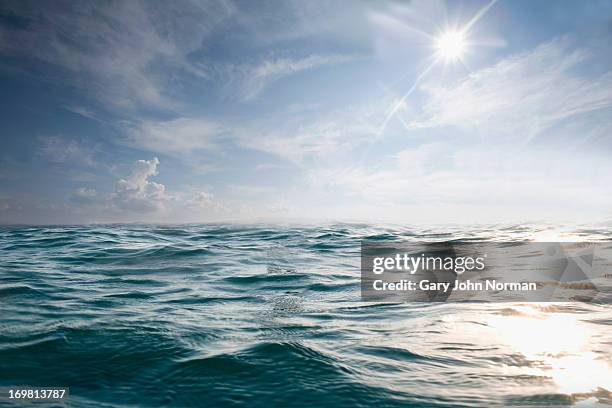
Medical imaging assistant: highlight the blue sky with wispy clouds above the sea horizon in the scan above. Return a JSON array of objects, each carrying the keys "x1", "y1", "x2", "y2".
[{"x1": 0, "y1": 0, "x2": 612, "y2": 224}]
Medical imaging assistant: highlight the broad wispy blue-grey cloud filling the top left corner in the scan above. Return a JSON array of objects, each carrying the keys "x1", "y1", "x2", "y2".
[{"x1": 0, "y1": 0, "x2": 234, "y2": 109}]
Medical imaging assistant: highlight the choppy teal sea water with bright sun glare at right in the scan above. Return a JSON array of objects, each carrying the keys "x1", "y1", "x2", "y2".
[{"x1": 0, "y1": 225, "x2": 612, "y2": 407}]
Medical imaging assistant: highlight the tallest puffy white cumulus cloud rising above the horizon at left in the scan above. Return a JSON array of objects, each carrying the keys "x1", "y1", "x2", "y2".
[{"x1": 113, "y1": 157, "x2": 168, "y2": 212}]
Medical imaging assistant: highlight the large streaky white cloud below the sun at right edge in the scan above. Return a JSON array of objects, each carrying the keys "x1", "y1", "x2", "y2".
[{"x1": 410, "y1": 39, "x2": 612, "y2": 142}]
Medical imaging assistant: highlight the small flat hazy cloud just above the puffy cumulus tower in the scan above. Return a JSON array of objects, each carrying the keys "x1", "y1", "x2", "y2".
[{"x1": 126, "y1": 118, "x2": 225, "y2": 154}]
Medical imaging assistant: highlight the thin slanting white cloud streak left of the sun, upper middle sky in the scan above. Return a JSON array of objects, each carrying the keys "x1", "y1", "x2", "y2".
[{"x1": 241, "y1": 55, "x2": 355, "y2": 101}]
